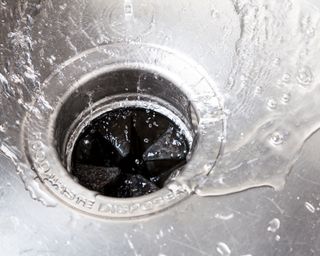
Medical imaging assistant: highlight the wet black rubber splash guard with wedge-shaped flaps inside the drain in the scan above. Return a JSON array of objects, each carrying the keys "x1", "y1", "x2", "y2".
[{"x1": 71, "y1": 107, "x2": 189, "y2": 198}]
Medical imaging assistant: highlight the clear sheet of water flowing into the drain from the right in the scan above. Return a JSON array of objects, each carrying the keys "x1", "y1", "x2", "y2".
[{"x1": 196, "y1": 0, "x2": 320, "y2": 196}]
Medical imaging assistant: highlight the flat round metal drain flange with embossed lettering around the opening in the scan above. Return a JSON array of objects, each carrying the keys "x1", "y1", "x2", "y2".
[{"x1": 23, "y1": 44, "x2": 224, "y2": 218}]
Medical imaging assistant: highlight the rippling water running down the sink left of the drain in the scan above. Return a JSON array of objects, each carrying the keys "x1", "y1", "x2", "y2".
[{"x1": 0, "y1": 1, "x2": 56, "y2": 207}]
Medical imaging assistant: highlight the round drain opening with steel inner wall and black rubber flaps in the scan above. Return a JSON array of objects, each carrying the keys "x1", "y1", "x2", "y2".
[{"x1": 54, "y1": 69, "x2": 198, "y2": 198}]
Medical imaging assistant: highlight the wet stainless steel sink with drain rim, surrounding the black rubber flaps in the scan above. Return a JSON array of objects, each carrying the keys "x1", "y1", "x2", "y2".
[{"x1": 0, "y1": 0, "x2": 320, "y2": 256}]
